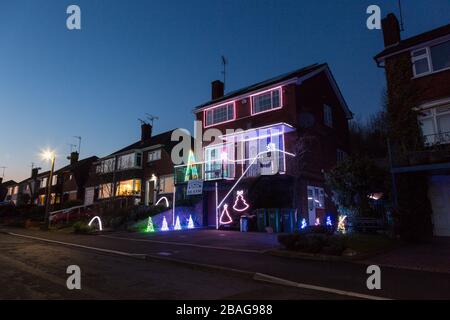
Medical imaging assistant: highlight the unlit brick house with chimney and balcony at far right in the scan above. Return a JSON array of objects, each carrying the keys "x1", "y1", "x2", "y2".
[{"x1": 375, "y1": 14, "x2": 450, "y2": 236}]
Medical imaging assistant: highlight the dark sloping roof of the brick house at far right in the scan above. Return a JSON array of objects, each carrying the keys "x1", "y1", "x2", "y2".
[{"x1": 374, "y1": 24, "x2": 450, "y2": 61}]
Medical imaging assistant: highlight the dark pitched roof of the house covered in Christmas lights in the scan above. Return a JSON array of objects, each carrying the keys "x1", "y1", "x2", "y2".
[{"x1": 195, "y1": 63, "x2": 327, "y2": 110}]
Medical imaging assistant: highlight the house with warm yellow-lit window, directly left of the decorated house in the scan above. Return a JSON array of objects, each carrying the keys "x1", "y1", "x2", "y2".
[{"x1": 85, "y1": 123, "x2": 178, "y2": 206}]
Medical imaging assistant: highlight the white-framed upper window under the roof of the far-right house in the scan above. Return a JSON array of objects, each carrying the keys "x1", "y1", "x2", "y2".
[{"x1": 411, "y1": 41, "x2": 450, "y2": 77}]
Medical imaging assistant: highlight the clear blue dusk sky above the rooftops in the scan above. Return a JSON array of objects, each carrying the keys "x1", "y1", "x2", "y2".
[{"x1": 0, "y1": 0, "x2": 450, "y2": 180}]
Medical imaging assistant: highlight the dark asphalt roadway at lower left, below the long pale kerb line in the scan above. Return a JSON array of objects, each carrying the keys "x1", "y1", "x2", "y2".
[{"x1": 0, "y1": 233, "x2": 343, "y2": 299}]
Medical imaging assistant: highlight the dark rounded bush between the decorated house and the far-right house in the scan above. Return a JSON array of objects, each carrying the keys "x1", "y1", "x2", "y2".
[{"x1": 325, "y1": 157, "x2": 387, "y2": 216}]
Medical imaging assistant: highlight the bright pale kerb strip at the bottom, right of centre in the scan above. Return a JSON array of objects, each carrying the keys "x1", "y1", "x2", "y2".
[{"x1": 253, "y1": 273, "x2": 392, "y2": 300}]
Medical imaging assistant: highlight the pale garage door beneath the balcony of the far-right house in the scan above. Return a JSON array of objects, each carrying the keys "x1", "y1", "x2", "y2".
[{"x1": 428, "y1": 175, "x2": 450, "y2": 237}]
